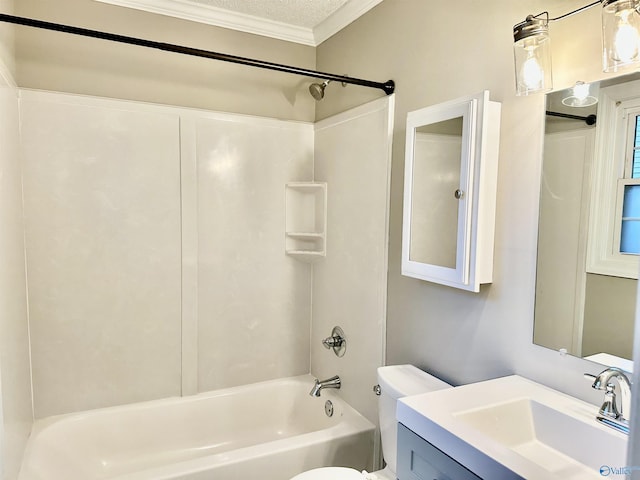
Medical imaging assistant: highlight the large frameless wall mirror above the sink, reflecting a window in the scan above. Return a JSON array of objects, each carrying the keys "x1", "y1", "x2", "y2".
[{"x1": 533, "y1": 74, "x2": 640, "y2": 370}]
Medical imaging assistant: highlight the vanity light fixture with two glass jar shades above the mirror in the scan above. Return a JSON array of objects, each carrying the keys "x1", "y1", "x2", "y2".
[{"x1": 513, "y1": 0, "x2": 640, "y2": 95}]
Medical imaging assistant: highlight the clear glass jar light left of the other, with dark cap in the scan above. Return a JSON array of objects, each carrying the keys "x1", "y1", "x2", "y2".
[{"x1": 513, "y1": 17, "x2": 552, "y2": 95}]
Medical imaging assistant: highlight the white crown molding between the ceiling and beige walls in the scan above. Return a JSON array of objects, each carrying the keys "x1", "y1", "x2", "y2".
[{"x1": 96, "y1": 0, "x2": 382, "y2": 47}]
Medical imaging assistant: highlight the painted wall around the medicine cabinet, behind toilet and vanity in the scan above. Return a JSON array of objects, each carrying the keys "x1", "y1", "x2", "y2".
[{"x1": 317, "y1": 0, "x2": 620, "y2": 403}]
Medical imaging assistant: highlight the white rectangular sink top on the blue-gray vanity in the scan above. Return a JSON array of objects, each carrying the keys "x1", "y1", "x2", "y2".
[{"x1": 397, "y1": 375, "x2": 627, "y2": 480}]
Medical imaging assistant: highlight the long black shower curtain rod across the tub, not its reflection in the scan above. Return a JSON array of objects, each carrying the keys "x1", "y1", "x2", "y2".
[{"x1": 0, "y1": 13, "x2": 395, "y2": 95}]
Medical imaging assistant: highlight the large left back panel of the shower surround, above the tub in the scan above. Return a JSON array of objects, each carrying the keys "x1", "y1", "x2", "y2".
[{"x1": 21, "y1": 92, "x2": 181, "y2": 417}]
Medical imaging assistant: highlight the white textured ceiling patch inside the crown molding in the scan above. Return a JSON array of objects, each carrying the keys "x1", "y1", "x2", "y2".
[{"x1": 192, "y1": 0, "x2": 348, "y2": 28}]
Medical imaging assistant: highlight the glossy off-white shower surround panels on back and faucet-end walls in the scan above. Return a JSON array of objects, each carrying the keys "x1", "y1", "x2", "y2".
[{"x1": 20, "y1": 90, "x2": 393, "y2": 422}]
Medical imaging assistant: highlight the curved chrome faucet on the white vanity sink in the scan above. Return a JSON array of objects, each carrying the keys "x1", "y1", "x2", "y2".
[{"x1": 586, "y1": 367, "x2": 631, "y2": 434}]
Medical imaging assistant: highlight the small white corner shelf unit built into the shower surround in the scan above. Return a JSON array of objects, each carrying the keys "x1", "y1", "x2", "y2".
[{"x1": 285, "y1": 182, "x2": 327, "y2": 262}]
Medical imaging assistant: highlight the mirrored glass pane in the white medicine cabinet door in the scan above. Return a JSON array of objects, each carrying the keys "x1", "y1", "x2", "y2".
[{"x1": 409, "y1": 117, "x2": 463, "y2": 269}]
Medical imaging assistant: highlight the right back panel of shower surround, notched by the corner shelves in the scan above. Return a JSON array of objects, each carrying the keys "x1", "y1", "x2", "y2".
[{"x1": 197, "y1": 119, "x2": 313, "y2": 391}]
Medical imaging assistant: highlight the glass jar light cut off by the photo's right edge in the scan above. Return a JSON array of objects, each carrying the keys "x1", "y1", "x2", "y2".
[{"x1": 602, "y1": 0, "x2": 640, "y2": 72}]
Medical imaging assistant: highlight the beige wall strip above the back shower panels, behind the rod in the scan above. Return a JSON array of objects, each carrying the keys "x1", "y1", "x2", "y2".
[{"x1": 16, "y1": 0, "x2": 315, "y2": 121}]
